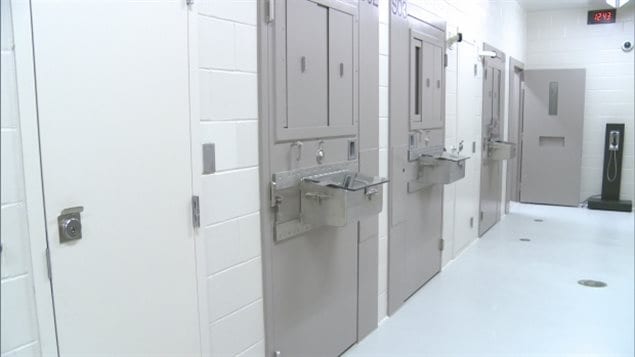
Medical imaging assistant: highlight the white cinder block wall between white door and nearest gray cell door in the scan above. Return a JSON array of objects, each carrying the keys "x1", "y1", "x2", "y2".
[{"x1": 195, "y1": 0, "x2": 264, "y2": 356}]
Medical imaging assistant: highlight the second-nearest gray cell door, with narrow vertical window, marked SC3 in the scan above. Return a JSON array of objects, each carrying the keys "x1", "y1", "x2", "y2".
[{"x1": 388, "y1": 14, "x2": 445, "y2": 314}]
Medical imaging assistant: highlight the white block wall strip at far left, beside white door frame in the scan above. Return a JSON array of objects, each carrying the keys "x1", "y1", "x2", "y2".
[{"x1": 0, "y1": 0, "x2": 40, "y2": 357}]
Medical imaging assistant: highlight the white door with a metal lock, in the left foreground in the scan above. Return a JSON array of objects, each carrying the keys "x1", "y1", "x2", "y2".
[{"x1": 32, "y1": 0, "x2": 200, "y2": 356}]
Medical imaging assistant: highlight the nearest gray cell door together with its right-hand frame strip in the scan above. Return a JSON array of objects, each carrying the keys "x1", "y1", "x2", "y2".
[{"x1": 259, "y1": 0, "x2": 378, "y2": 356}]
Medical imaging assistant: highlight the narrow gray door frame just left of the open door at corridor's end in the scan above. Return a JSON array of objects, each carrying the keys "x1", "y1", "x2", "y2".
[{"x1": 505, "y1": 56, "x2": 525, "y2": 213}]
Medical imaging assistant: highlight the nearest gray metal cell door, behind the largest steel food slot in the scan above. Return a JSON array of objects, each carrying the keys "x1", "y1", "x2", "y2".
[{"x1": 261, "y1": 0, "x2": 368, "y2": 356}]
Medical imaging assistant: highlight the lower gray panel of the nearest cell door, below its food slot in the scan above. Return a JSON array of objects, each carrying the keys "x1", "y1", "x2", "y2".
[{"x1": 272, "y1": 225, "x2": 357, "y2": 356}]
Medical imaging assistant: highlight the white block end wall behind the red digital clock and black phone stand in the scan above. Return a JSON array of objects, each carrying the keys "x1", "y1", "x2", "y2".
[{"x1": 525, "y1": 1, "x2": 635, "y2": 201}]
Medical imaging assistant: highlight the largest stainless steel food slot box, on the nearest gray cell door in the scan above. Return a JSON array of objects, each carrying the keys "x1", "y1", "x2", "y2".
[{"x1": 271, "y1": 162, "x2": 388, "y2": 240}]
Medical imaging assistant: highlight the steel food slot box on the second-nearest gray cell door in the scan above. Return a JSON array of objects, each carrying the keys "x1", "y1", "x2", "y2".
[{"x1": 408, "y1": 151, "x2": 470, "y2": 192}]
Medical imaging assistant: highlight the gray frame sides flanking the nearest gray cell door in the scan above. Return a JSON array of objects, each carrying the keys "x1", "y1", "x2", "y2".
[{"x1": 256, "y1": 0, "x2": 379, "y2": 356}]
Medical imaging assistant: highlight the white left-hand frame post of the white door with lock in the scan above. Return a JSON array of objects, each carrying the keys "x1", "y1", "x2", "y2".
[{"x1": 10, "y1": 0, "x2": 59, "y2": 356}]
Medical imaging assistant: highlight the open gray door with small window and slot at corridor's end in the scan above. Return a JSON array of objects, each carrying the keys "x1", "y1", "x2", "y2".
[{"x1": 520, "y1": 69, "x2": 586, "y2": 206}]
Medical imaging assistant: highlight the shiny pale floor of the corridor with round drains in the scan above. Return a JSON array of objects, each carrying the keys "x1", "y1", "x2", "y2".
[{"x1": 346, "y1": 204, "x2": 635, "y2": 357}]
